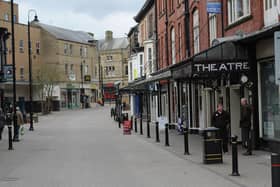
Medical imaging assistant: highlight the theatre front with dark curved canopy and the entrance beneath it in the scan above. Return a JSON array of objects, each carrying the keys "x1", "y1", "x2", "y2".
[{"x1": 172, "y1": 41, "x2": 253, "y2": 141}]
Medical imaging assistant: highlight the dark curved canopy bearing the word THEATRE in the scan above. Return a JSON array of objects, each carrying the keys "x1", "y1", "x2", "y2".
[{"x1": 172, "y1": 41, "x2": 250, "y2": 79}]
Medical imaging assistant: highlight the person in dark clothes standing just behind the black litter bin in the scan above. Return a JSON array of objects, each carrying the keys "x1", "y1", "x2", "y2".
[{"x1": 212, "y1": 103, "x2": 230, "y2": 153}]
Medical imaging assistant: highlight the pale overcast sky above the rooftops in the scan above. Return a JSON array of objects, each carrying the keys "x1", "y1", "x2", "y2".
[{"x1": 15, "y1": 0, "x2": 145, "y2": 39}]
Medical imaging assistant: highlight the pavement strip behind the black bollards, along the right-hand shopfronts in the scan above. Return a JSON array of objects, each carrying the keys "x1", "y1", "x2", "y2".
[{"x1": 133, "y1": 120, "x2": 271, "y2": 187}]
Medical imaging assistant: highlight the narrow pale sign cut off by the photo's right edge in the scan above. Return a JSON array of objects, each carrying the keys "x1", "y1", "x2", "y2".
[{"x1": 274, "y1": 31, "x2": 280, "y2": 85}]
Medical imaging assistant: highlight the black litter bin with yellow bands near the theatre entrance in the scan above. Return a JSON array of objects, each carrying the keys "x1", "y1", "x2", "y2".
[{"x1": 200, "y1": 127, "x2": 223, "y2": 164}]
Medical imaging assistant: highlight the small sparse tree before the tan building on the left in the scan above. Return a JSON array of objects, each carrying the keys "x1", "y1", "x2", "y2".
[{"x1": 34, "y1": 64, "x2": 62, "y2": 114}]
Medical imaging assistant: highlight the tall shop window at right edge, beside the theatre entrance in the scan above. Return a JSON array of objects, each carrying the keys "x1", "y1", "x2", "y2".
[{"x1": 260, "y1": 62, "x2": 280, "y2": 141}]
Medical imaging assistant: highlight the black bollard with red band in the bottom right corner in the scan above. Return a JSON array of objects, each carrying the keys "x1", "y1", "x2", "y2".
[{"x1": 271, "y1": 153, "x2": 280, "y2": 187}]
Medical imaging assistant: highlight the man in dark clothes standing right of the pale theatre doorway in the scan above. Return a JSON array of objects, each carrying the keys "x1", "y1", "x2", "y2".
[{"x1": 240, "y1": 98, "x2": 252, "y2": 156}]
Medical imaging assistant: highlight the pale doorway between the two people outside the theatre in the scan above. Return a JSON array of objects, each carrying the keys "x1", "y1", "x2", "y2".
[{"x1": 230, "y1": 86, "x2": 241, "y2": 139}]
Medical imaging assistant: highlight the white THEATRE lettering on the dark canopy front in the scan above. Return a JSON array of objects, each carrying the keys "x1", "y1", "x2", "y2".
[{"x1": 193, "y1": 62, "x2": 250, "y2": 74}]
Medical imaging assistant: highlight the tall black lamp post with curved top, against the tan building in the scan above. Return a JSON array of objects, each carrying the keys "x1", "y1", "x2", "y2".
[{"x1": 28, "y1": 9, "x2": 38, "y2": 131}]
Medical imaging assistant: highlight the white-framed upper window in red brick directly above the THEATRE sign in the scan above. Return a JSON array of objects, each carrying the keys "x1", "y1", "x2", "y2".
[{"x1": 228, "y1": 0, "x2": 251, "y2": 24}]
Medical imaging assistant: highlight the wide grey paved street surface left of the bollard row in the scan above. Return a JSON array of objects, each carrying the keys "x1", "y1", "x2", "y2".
[{"x1": 0, "y1": 107, "x2": 269, "y2": 187}]
